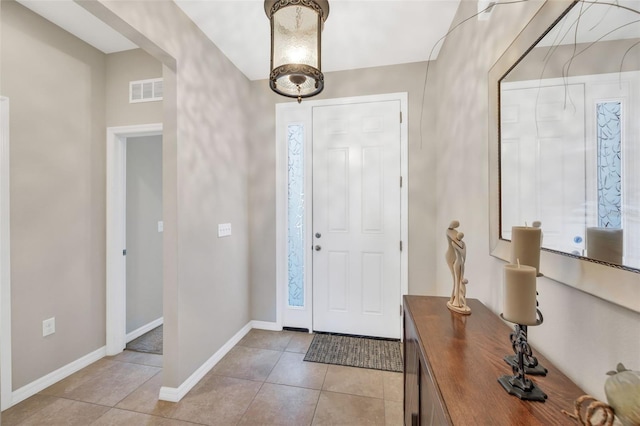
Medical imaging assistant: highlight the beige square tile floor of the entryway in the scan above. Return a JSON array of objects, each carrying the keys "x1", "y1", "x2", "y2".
[{"x1": 0, "y1": 330, "x2": 403, "y2": 426}]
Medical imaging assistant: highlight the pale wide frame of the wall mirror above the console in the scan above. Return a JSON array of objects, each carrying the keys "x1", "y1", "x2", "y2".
[{"x1": 489, "y1": 0, "x2": 640, "y2": 312}]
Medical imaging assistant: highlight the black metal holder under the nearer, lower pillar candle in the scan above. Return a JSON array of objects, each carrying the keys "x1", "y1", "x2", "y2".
[{"x1": 498, "y1": 309, "x2": 547, "y2": 402}]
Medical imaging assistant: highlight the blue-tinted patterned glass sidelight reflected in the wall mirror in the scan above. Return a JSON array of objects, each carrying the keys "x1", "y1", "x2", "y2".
[{"x1": 596, "y1": 102, "x2": 622, "y2": 229}]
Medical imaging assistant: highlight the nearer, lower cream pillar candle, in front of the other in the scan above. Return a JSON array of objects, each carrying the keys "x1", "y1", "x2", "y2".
[{"x1": 502, "y1": 265, "x2": 536, "y2": 325}]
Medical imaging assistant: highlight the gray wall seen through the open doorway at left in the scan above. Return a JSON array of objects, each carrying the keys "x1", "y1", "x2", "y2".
[{"x1": 126, "y1": 136, "x2": 162, "y2": 333}]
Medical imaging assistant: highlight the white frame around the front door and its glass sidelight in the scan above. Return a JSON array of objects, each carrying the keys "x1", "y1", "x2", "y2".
[{"x1": 276, "y1": 92, "x2": 409, "y2": 336}]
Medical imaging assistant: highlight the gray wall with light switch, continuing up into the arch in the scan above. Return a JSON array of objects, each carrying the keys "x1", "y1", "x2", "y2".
[{"x1": 83, "y1": 0, "x2": 253, "y2": 387}]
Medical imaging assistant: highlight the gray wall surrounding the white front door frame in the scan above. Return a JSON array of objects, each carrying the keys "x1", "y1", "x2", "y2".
[{"x1": 249, "y1": 62, "x2": 439, "y2": 321}]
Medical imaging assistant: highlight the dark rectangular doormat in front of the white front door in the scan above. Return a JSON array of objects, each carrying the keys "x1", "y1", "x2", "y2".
[{"x1": 304, "y1": 333, "x2": 403, "y2": 372}]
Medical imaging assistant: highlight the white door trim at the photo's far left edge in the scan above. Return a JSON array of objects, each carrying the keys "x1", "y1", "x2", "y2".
[{"x1": 0, "y1": 96, "x2": 13, "y2": 410}]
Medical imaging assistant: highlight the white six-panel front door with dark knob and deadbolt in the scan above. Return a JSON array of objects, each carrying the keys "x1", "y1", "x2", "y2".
[{"x1": 312, "y1": 101, "x2": 401, "y2": 338}]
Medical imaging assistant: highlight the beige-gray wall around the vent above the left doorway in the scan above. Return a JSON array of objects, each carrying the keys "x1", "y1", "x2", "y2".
[{"x1": 105, "y1": 49, "x2": 162, "y2": 127}]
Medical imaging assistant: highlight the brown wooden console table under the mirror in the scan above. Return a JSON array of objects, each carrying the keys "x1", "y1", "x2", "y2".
[{"x1": 404, "y1": 296, "x2": 584, "y2": 426}]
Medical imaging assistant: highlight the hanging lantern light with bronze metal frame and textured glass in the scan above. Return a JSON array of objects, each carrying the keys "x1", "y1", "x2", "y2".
[{"x1": 264, "y1": 0, "x2": 329, "y2": 103}]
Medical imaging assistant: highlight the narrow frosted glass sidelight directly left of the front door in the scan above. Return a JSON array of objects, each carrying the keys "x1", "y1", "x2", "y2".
[{"x1": 287, "y1": 124, "x2": 304, "y2": 307}]
